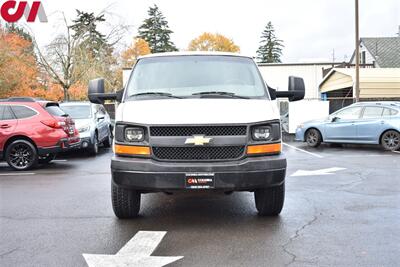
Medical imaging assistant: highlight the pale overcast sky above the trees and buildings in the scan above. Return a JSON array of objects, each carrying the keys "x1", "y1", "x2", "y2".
[{"x1": 29, "y1": 0, "x2": 400, "y2": 62}]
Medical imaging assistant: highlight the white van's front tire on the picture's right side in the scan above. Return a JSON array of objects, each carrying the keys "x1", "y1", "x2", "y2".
[{"x1": 254, "y1": 184, "x2": 285, "y2": 216}]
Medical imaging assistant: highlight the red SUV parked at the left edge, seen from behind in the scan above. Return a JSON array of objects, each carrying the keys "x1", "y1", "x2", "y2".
[{"x1": 0, "y1": 98, "x2": 80, "y2": 170}]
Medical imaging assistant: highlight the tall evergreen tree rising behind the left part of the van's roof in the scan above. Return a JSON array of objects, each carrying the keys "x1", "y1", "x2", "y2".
[{"x1": 138, "y1": 5, "x2": 178, "y2": 53}]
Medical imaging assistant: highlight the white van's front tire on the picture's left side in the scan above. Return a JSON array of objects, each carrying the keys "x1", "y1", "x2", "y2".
[{"x1": 111, "y1": 183, "x2": 140, "y2": 219}]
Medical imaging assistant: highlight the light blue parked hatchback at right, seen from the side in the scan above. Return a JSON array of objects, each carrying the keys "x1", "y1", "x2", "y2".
[{"x1": 296, "y1": 101, "x2": 400, "y2": 150}]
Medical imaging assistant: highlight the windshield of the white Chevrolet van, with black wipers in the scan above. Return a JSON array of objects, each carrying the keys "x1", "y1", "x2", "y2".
[{"x1": 125, "y1": 56, "x2": 268, "y2": 100}]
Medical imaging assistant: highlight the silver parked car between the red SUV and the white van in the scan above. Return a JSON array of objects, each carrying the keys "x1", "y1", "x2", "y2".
[{"x1": 60, "y1": 102, "x2": 113, "y2": 155}]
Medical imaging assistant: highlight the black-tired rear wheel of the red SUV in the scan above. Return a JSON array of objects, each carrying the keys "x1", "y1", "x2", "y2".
[{"x1": 5, "y1": 140, "x2": 38, "y2": 171}]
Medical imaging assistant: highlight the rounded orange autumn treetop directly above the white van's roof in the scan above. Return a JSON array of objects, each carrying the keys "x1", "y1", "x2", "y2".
[{"x1": 188, "y1": 32, "x2": 240, "y2": 53}]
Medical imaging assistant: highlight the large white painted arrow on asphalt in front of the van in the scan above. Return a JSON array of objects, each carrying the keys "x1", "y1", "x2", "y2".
[{"x1": 83, "y1": 231, "x2": 183, "y2": 267}]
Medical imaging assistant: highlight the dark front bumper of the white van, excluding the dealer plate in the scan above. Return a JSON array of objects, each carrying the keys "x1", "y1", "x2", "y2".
[{"x1": 111, "y1": 155, "x2": 286, "y2": 192}]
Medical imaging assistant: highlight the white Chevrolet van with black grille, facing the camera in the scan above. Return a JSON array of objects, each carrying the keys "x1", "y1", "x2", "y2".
[{"x1": 89, "y1": 52, "x2": 304, "y2": 218}]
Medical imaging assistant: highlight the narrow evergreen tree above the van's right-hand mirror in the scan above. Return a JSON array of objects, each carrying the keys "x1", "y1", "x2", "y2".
[{"x1": 257, "y1": 21, "x2": 284, "y2": 63}]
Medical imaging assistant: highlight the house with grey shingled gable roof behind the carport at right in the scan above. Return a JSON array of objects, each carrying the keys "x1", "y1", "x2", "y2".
[{"x1": 350, "y1": 37, "x2": 400, "y2": 68}]
